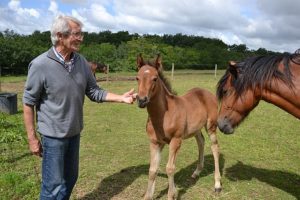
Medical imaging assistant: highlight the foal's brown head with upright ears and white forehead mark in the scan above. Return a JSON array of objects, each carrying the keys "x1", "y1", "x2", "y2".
[{"x1": 136, "y1": 55, "x2": 162, "y2": 108}]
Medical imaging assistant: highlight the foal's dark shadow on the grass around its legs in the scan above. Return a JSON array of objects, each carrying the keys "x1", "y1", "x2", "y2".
[{"x1": 80, "y1": 154, "x2": 224, "y2": 200}]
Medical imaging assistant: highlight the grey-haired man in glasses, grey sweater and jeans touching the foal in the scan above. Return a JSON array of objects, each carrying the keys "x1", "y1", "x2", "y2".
[{"x1": 23, "y1": 16, "x2": 134, "y2": 199}]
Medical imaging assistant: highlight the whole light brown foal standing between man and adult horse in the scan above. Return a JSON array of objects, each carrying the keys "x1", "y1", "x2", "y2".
[{"x1": 136, "y1": 55, "x2": 221, "y2": 199}]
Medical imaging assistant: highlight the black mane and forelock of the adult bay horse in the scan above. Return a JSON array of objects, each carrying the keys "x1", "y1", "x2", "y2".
[{"x1": 217, "y1": 53, "x2": 296, "y2": 100}]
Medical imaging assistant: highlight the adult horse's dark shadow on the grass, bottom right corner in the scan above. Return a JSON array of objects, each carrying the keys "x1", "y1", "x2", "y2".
[{"x1": 226, "y1": 161, "x2": 300, "y2": 199}]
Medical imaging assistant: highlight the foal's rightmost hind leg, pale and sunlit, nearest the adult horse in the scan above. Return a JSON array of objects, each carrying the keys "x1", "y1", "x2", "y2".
[{"x1": 208, "y1": 123, "x2": 222, "y2": 192}]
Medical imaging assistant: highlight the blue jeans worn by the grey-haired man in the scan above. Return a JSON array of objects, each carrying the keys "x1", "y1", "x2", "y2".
[{"x1": 40, "y1": 134, "x2": 80, "y2": 200}]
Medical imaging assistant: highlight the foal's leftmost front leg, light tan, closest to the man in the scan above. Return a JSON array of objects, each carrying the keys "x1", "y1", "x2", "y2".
[{"x1": 144, "y1": 142, "x2": 164, "y2": 200}]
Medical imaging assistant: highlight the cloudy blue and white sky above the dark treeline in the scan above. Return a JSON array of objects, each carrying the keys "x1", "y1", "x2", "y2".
[{"x1": 0, "y1": 0, "x2": 300, "y2": 53}]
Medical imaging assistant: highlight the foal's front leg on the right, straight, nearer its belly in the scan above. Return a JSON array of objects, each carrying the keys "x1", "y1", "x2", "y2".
[{"x1": 166, "y1": 138, "x2": 182, "y2": 200}]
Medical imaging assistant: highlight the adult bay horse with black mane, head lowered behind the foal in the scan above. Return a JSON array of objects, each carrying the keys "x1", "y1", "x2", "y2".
[{"x1": 217, "y1": 52, "x2": 300, "y2": 134}]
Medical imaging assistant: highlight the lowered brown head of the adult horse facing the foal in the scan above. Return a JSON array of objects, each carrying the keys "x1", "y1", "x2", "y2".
[{"x1": 217, "y1": 61, "x2": 259, "y2": 134}]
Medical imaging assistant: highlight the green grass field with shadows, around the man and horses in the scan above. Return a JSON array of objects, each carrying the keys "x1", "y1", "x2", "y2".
[{"x1": 0, "y1": 71, "x2": 300, "y2": 200}]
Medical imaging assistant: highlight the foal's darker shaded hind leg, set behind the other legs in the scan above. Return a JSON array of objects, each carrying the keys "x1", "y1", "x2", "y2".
[{"x1": 192, "y1": 131, "x2": 205, "y2": 178}]
